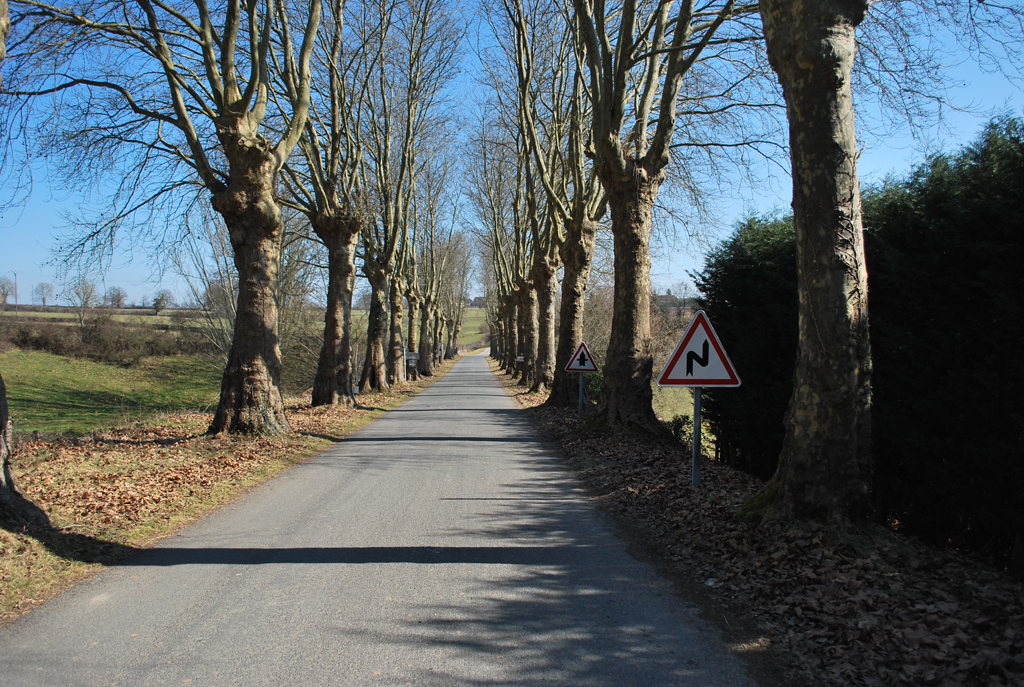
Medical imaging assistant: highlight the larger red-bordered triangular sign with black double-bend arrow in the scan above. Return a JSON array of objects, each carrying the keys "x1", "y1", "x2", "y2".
[{"x1": 657, "y1": 310, "x2": 739, "y2": 386}]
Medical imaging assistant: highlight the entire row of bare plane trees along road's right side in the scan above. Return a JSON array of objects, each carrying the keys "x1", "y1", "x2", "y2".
[{"x1": 473, "y1": 0, "x2": 1022, "y2": 518}]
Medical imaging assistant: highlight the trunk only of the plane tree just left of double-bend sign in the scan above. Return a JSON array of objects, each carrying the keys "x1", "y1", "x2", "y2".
[{"x1": 598, "y1": 168, "x2": 666, "y2": 435}]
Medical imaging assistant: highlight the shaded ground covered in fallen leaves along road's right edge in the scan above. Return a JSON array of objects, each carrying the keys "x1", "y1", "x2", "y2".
[{"x1": 489, "y1": 362, "x2": 1024, "y2": 686}]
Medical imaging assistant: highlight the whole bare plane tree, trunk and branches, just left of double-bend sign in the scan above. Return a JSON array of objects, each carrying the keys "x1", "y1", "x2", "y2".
[{"x1": 572, "y1": 0, "x2": 757, "y2": 433}]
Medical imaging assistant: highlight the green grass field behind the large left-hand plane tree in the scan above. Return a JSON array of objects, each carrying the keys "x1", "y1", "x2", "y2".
[{"x1": 0, "y1": 350, "x2": 220, "y2": 434}]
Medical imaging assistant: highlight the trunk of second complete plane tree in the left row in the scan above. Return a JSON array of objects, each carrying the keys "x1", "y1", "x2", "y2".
[{"x1": 312, "y1": 217, "x2": 360, "y2": 406}]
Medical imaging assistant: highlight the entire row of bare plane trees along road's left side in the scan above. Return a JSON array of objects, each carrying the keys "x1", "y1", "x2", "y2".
[{"x1": 2, "y1": 0, "x2": 469, "y2": 433}]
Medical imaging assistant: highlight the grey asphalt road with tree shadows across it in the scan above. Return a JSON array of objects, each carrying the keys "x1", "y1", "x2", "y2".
[{"x1": 0, "y1": 356, "x2": 754, "y2": 687}]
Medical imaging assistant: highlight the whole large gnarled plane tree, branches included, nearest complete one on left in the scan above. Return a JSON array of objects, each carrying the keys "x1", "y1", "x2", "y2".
[{"x1": 8, "y1": 0, "x2": 321, "y2": 434}]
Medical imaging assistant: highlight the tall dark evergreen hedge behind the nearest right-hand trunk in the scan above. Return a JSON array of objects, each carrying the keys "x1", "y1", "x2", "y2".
[{"x1": 693, "y1": 118, "x2": 1024, "y2": 575}]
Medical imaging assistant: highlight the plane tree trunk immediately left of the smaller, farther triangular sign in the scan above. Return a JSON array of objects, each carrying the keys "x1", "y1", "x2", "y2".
[{"x1": 545, "y1": 218, "x2": 597, "y2": 407}]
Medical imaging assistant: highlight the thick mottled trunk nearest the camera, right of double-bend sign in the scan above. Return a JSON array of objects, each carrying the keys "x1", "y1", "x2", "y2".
[{"x1": 761, "y1": 0, "x2": 871, "y2": 518}]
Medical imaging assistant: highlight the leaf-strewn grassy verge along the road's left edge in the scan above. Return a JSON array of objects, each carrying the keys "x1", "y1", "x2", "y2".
[{"x1": 0, "y1": 362, "x2": 452, "y2": 625}]
